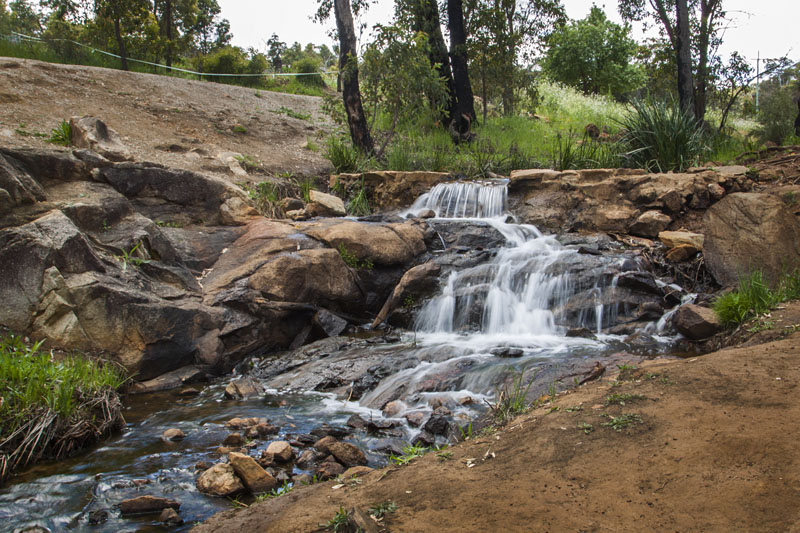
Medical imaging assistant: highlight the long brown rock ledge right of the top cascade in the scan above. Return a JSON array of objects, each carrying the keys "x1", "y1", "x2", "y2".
[{"x1": 509, "y1": 167, "x2": 752, "y2": 233}]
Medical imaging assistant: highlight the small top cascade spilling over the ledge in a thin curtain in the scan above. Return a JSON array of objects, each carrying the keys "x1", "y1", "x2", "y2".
[{"x1": 408, "y1": 180, "x2": 508, "y2": 218}]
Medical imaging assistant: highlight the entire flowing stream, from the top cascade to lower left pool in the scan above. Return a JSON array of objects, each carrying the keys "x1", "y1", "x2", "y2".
[{"x1": 0, "y1": 181, "x2": 688, "y2": 531}]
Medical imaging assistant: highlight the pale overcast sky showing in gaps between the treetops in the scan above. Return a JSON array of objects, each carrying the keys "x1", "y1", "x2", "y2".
[{"x1": 219, "y1": 0, "x2": 800, "y2": 66}]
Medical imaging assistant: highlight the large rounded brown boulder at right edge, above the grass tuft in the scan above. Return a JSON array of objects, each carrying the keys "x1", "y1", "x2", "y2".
[{"x1": 703, "y1": 193, "x2": 800, "y2": 286}]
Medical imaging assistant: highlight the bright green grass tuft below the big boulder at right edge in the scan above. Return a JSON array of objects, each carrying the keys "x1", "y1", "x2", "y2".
[{"x1": 713, "y1": 270, "x2": 800, "y2": 327}]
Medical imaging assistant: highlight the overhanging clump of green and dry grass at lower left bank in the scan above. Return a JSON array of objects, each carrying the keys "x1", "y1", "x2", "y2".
[{"x1": 0, "y1": 333, "x2": 125, "y2": 481}]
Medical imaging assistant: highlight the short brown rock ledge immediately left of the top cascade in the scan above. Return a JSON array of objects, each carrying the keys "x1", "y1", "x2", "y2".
[{"x1": 330, "y1": 170, "x2": 451, "y2": 210}]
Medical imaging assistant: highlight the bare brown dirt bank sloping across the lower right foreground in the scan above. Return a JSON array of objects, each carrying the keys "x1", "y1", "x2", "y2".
[{"x1": 194, "y1": 302, "x2": 800, "y2": 533}]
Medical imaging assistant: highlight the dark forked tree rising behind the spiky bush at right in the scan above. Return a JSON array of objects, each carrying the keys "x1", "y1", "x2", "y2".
[{"x1": 619, "y1": 0, "x2": 726, "y2": 122}]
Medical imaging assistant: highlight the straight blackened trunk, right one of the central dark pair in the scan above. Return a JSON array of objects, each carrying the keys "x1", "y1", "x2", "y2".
[{"x1": 447, "y1": 0, "x2": 475, "y2": 135}]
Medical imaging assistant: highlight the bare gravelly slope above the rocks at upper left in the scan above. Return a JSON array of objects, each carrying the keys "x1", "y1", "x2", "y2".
[{"x1": 0, "y1": 58, "x2": 329, "y2": 181}]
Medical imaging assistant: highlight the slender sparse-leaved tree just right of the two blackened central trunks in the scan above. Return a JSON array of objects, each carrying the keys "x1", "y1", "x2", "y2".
[{"x1": 464, "y1": 0, "x2": 565, "y2": 115}]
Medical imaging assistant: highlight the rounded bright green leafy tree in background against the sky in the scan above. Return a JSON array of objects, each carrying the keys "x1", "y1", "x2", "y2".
[{"x1": 543, "y1": 6, "x2": 644, "y2": 95}]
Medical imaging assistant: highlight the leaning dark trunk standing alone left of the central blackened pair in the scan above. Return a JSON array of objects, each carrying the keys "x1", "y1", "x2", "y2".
[{"x1": 334, "y1": 0, "x2": 375, "y2": 155}]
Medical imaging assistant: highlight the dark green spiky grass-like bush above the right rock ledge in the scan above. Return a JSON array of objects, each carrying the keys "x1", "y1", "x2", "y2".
[{"x1": 619, "y1": 98, "x2": 707, "y2": 172}]
